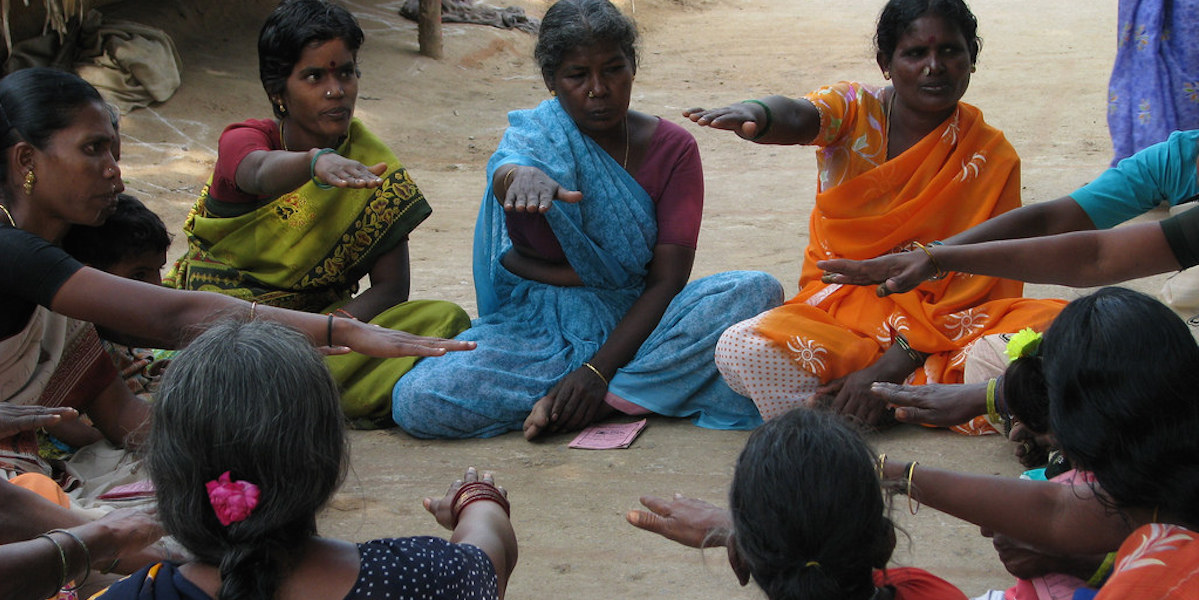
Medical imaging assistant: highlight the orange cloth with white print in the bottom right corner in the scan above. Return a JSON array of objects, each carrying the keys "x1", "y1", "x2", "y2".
[{"x1": 1095, "y1": 523, "x2": 1199, "y2": 600}]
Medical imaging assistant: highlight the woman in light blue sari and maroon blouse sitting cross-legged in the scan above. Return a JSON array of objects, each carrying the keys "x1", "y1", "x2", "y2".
[{"x1": 392, "y1": 0, "x2": 782, "y2": 438}]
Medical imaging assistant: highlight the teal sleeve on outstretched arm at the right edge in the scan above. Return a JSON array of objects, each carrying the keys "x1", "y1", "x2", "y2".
[{"x1": 1070, "y1": 130, "x2": 1199, "y2": 229}]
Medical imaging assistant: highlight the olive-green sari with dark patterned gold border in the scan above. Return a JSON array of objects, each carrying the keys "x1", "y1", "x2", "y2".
[{"x1": 163, "y1": 119, "x2": 470, "y2": 426}]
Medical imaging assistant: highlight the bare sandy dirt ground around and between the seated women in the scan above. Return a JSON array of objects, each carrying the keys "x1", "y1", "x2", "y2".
[{"x1": 104, "y1": 0, "x2": 1161, "y2": 600}]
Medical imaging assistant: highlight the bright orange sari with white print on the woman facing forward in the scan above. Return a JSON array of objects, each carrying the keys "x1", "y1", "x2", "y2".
[{"x1": 758, "y1": 83, "x2": 1065, "y2": 433}]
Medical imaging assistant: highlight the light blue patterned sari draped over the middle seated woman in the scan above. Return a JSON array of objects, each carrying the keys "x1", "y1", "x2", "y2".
[{"x1": 392, "y1": 100, "x2": 782, "y2": 438}]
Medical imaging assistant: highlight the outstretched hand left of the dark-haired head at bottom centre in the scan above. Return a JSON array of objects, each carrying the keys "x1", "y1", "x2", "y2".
[{"x1": 625, "y1": 493, "x2": 733, "y2": 548}]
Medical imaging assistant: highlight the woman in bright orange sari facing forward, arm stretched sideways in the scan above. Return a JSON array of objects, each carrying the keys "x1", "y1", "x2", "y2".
[{"x1": 685, "y1": 0, "x2": 1062, "y2": 433}]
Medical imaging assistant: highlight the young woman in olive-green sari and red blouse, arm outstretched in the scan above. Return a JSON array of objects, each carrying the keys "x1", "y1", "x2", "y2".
[{"x1": 164, "y1": 0, "x2": 470, "y2": 426}]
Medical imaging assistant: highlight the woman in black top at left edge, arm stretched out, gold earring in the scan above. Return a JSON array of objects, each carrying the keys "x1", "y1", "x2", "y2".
[{"x1": 0, "y1": 68, "x2": 474, "y2": 580}]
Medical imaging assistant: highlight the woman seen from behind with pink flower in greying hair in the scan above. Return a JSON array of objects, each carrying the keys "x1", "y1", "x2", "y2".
[{"x1": 87, "y1": 320, "x2": 517, "y2": 600}]
